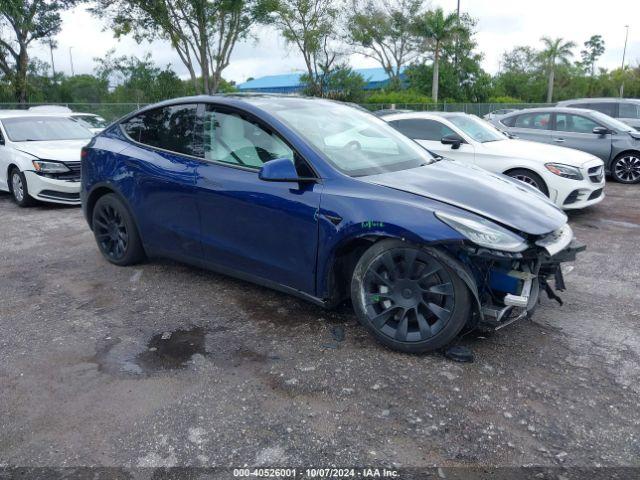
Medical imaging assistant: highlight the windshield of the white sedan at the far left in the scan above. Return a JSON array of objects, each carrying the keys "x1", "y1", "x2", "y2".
[{"x1": 2, "y1": 117, "x2": 93, "y2": 142}]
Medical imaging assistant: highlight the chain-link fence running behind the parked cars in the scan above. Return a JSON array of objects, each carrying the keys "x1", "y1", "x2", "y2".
[{"x1": 0, "y1": 103, "x2": 549, "y2": 121}]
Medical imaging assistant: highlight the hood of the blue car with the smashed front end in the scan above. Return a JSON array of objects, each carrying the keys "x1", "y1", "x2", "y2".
[{"x1": 360, "y1": 159, "x2": 567, "y2": 235}]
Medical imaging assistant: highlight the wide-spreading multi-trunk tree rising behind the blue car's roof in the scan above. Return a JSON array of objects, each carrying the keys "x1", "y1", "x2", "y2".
[{"x1": 92, "y1": 0, "x2": 263, "y2": 93}]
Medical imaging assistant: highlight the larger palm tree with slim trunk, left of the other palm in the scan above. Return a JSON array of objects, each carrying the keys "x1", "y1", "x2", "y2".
[{"x1": 417, "y1": 7, "x2": 460, "y2": 102}]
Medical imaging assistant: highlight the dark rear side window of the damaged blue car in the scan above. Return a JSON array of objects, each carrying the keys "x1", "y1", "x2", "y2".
[{"x1": 122, "y1": 104, "x2": 199, "y2": 155}]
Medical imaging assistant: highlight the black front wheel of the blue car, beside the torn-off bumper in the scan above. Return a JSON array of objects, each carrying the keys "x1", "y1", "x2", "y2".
[{"x1": 351, "y1": 240, "x2": 470, "y2": 353}]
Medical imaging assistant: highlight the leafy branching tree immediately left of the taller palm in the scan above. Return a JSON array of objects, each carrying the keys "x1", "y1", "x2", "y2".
[{"x1": 345, "y1": 0, "x2": 423, "y2": 87}]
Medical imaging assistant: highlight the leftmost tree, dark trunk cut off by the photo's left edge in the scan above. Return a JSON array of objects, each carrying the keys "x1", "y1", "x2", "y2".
[{"x1": 0, "y1": 0, "x2": 78, "y2": 103}]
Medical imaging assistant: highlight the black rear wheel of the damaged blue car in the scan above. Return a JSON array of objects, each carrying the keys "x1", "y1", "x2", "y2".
[{"x1": 91, "y1": 193, "x2": 144, "y2": 266}]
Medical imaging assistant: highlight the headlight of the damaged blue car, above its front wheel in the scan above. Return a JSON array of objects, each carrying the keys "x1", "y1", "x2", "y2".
[{"x1": 435, "y1": 212, "x2": 528, "y2": 252}]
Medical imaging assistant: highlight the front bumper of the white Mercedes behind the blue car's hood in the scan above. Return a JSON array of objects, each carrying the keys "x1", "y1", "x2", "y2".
[{"x1": 549, "y1": 160, "x2": 605, "y2": 210}]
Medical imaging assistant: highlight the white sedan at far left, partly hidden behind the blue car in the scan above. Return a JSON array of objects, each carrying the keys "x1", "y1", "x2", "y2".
[{"x1": 0, "y1": 110, "x2": 93, "y2": 207}]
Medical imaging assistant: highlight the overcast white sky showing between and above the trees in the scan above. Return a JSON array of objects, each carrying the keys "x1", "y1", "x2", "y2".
[{"x1": 32, "y1": 0, "x2": 640, "y2": 83}]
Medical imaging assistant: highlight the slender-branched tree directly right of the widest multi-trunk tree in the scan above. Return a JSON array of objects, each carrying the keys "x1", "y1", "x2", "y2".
[{"x1": 265, "y1": 0, "x2": 341, "y2": 96}]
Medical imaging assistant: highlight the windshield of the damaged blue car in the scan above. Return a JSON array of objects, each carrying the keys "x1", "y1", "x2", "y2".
[{"x1": 245, "y1": 98, "x2": 433, "y2": 177}]
